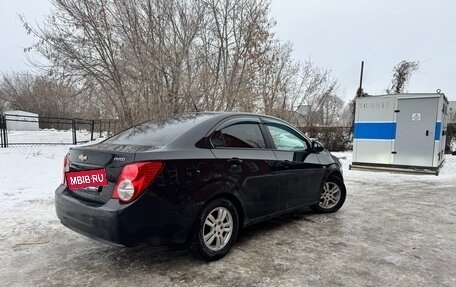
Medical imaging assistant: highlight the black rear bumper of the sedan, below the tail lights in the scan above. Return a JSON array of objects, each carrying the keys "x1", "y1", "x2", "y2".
[{"x1": 55, "y1": 185, "x2": 194, "y2": 246}]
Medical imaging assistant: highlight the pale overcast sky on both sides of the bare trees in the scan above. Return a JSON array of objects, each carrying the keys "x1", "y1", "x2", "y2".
[{"x1": 0, "y1": 0, "x2": 456, "y2": 100}]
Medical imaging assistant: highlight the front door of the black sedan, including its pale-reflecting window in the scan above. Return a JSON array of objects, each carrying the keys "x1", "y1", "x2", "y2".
[{"x1": 263, "y1": 118, "x2": 326, "y2": 210}]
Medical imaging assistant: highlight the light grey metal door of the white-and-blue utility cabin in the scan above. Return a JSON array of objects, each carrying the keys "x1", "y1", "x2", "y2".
[{"x1": 393, "y1": 98, "x2": 438, "y2": 167}]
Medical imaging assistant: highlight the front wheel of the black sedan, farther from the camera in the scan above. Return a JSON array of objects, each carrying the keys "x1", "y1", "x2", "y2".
[{"x1": 312, "y1": 176, "x2": 347, "y2": 213}]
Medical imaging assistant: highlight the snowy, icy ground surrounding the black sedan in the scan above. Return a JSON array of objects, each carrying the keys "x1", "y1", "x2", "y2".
[{"x1": 0, "y1": 140, "x2": 456, "y2": 286}]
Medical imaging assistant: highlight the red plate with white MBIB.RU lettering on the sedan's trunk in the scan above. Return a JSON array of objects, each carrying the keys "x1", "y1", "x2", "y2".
[{"x1": 65, "y1": 168, "x2": 108, "y2": 189}]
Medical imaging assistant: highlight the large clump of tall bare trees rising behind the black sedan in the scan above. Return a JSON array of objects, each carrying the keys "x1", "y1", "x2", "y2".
[{"x1": 23, "y1": 0, "x2": 337, "y2": 127}]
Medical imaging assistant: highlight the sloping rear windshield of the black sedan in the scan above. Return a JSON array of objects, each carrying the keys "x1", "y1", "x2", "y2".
[{"x1": 104, "y1": 113, "x2": 212, "y2": 147}]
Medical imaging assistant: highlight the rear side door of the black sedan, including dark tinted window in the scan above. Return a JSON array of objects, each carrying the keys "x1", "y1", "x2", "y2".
[{"x1": 211, "y1": 116, "x2": 281, "y2": 219}]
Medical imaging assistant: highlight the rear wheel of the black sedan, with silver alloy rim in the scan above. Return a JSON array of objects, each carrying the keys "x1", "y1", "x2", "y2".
[{"x1": 191, "y1": 198, "x2": 239, "y2": 261}]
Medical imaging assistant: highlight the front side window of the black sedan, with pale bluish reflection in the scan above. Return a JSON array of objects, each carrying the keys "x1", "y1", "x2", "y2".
[{"x1": 266, "y1": 123, "x2": 309, "y2": 150}]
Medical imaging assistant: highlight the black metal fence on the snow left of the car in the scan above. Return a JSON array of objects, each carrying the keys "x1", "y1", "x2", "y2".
[{"x1": 0, "y1": 115, "x2": 118, "y2": 147}]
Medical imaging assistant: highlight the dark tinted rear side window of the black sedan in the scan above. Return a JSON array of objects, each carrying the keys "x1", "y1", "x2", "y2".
[{"x1": 211, "y1": 123, "x2": 266, "y2": 148}]
